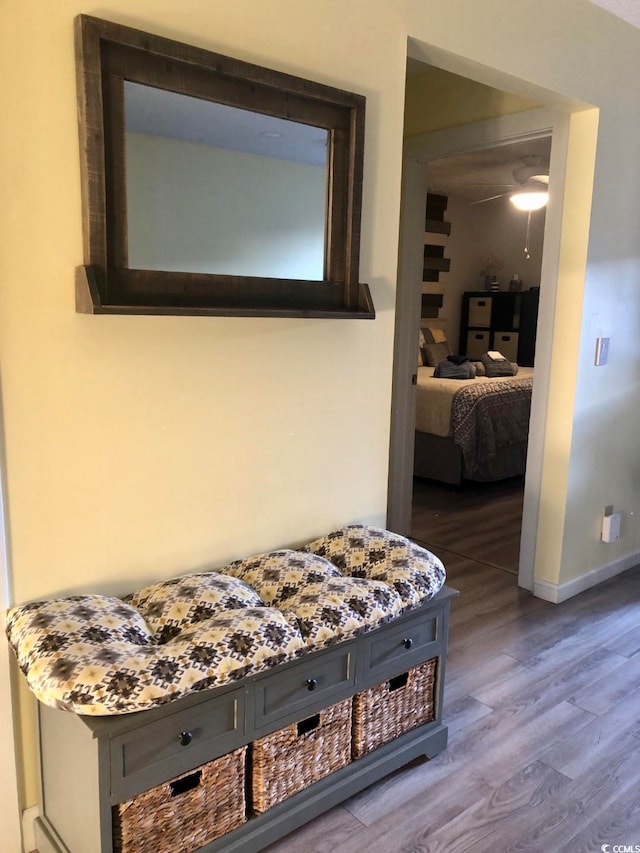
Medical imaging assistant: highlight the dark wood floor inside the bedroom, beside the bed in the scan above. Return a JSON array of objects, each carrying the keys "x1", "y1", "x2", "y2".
[{"x1": 411, "y1": 477, "x2": 524, "y2": 575}]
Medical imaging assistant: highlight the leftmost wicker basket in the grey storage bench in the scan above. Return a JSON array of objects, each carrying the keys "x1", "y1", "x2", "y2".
[{"x1": 113, "y1": 746, "x2": 247, "y2": 853}]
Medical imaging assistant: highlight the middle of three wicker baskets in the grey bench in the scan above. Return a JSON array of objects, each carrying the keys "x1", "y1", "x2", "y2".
[{"x1": 250, "y1": 699, "x2": 352, "y2": 814}]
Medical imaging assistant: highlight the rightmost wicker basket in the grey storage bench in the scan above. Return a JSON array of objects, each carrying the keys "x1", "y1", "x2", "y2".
[{"x1": 352, "y1": 658, "x2": 437, "y2": 758}]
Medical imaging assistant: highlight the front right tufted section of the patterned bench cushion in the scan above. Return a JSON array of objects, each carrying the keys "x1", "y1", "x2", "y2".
[{"x1": 282, "y1": 577, "x2": 403, "y2": 649}]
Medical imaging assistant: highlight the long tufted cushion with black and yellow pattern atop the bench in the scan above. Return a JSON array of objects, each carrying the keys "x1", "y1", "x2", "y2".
[{"x1": 7, "y1": 525, "x2": 444, "y2": 715}]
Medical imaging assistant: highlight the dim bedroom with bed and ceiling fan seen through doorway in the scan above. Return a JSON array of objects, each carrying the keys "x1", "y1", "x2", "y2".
[{"x1": 411, "y1": 135, "x2": 551, "y2": 576}]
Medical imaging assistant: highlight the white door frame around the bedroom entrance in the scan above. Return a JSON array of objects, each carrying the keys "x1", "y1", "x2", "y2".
[{"x1": 387, "y1": 107, "x2": 570, "y2": 591}]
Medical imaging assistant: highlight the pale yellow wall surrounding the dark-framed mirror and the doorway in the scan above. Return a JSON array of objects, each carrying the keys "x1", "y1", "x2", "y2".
[{"x1": 0, "y1": 0, "x2": 640, "y2": 816}]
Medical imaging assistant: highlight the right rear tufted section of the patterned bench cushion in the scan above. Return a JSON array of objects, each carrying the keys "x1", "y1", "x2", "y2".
[{"x1": 304, "y1": 524, "x2": 445, "y2": 607}]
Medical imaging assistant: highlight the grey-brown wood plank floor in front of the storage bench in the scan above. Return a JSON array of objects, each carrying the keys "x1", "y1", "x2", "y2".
[{"x1": 268, "y1": 548, "x2": 640, "y2": 853}]
